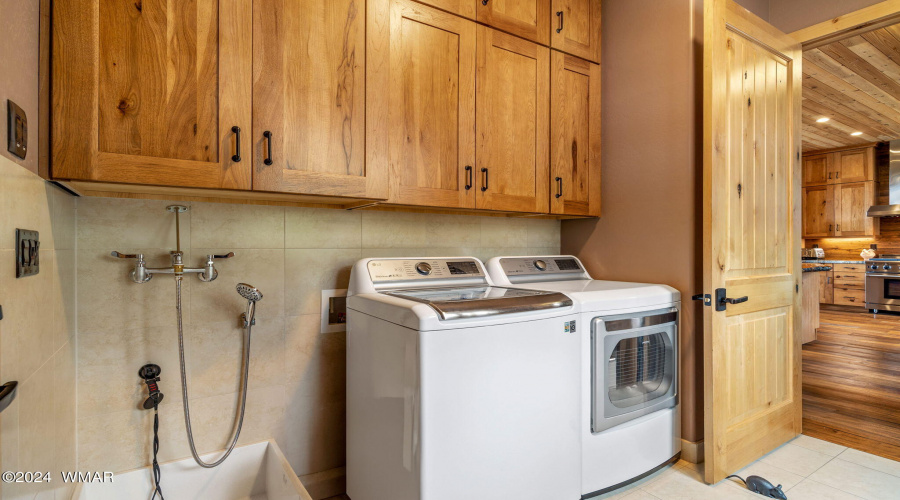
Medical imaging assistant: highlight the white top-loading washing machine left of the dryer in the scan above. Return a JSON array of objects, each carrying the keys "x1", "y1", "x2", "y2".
[{"x1": 347, "y1": 257, "x2": 581, "y2": 500}]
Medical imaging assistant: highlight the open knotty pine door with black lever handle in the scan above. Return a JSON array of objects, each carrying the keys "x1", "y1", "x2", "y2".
[{"x1": 703, "y1": 0, "x2": 802, "y2": 483}]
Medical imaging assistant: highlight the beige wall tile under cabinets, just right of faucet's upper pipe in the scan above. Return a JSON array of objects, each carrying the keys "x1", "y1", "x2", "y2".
[{"x1": 191, "y1": 203, "x2": 284, "y2": 251}]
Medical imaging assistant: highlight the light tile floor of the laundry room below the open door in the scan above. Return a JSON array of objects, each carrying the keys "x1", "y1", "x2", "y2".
[{"x1": 594, "y1": 435, "x2": 900, "y2": 500}]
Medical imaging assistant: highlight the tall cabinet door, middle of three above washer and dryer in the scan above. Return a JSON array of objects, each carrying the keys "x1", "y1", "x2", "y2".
[{"x1": 476, "y1": 26, "x2": 550, "y2": 213}]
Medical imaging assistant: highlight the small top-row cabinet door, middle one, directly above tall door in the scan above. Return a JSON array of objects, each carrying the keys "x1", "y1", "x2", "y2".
[{"x1": 472, "y1": 0, "x2": 550, "y2": 45}]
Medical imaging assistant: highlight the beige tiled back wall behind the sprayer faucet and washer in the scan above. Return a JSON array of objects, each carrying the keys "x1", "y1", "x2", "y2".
[{"x1": 77, "y1": 198, "x2": 559, "y2": 475}]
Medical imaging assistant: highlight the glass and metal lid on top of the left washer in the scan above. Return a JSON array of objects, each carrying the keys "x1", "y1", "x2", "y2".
[{"x1": 382, "y1": 286, "x2": 572, "y2": 320}]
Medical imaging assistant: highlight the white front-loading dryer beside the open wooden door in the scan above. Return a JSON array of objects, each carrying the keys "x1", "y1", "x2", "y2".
[{"x1": 487, "y1": 255, "x2": 681, "y2": 498}]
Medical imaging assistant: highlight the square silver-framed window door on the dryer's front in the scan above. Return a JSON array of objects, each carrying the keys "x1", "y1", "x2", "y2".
[{"x1": 591, "y1": 308, "x2": 678, "y2": 433}]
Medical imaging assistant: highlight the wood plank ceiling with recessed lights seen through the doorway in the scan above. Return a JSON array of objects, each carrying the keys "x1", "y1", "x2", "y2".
[{"x1": 802, "y1": 25, "x2": 900, "y2": 152}]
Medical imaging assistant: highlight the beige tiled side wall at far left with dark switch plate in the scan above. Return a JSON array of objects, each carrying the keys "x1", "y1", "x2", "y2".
[{"x1": 0, "y1": 157, "x2": 76, "y2": 499}]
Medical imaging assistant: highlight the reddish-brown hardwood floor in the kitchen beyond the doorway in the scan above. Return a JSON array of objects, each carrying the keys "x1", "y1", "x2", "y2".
[{"x1": 803, "y1": 306, "x2": 900, "y2": 460}]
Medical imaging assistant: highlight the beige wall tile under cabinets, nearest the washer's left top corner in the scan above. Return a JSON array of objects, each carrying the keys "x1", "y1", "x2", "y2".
[{"x1": 285, "y1": 207, "x2": 362, "y2": 248}]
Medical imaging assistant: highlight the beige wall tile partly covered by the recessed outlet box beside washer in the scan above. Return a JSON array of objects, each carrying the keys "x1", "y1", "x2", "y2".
[{"x1": 286, "y1": 249, "x2": 360, "y2": 316}]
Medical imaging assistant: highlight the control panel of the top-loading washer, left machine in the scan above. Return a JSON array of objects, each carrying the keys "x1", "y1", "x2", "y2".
[{"x1": 368, "y1": 258, "x2": 484, "y2": 283}]
